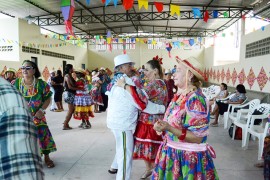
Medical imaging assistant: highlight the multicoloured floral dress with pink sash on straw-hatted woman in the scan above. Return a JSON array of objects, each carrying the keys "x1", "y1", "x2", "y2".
[{"x1": 152, "y1": 89, "x2": 219, "y2": 180}]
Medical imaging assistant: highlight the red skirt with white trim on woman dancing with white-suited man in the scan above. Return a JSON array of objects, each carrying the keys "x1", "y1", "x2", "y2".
[{"x1": 133, "y1": 121, "x2": 162, "y2": 162}]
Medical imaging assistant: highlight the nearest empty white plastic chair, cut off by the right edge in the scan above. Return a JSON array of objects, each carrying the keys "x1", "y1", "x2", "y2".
[{"x1": 244, "y1": 104, "x2": 270, "y2": 160}]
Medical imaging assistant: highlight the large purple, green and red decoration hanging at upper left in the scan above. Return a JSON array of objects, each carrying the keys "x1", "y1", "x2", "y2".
[{"x1": 61, "y1": 0, "x2": 75, "y2": 36}]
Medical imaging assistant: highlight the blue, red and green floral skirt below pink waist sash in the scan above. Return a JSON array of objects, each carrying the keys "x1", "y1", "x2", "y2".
[{"x1": 152, "y1": 144, "x2": 219, "y2": 180}]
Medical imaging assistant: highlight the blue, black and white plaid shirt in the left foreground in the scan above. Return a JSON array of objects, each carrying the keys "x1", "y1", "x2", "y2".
[{"x1": 0, "y1": 78, "x2": 44, "y2": 180}]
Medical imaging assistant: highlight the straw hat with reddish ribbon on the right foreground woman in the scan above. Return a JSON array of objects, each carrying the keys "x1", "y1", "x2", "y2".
[{"x1": 175, "y1": 56, "x2": 208, "y2": 81}]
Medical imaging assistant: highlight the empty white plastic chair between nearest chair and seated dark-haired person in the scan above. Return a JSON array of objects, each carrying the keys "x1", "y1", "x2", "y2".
[{"x1": 227, "y1": 99, "x2": 261, "y2": 129}]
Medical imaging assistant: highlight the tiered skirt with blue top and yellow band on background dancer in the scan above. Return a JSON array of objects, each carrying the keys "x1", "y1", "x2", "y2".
[{"x1": 73, "y1": 94, "x2": 94, "y2": 120}]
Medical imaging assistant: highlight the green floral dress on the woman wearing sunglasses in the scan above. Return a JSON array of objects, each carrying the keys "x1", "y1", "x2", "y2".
[{"x1": 14, "y1": 78, "x2": 56, "y2": 154}]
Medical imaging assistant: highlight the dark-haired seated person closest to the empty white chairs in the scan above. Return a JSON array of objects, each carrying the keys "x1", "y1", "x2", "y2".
[{"x1": 211, "y1": 84, "x2": 247, "y2": 127}]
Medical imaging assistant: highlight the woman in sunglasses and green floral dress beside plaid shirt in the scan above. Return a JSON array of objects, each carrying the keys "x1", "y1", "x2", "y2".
[{"x1": 15, "y1": 60, "x2": 56, "y2": 168}]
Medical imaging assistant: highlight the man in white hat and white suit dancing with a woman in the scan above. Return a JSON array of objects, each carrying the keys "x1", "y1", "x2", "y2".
[{"x1": 106, "y1": 54, "x2": 165, "y2": 180}]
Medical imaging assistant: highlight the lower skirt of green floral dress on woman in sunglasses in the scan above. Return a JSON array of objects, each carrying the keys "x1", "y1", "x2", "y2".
[{"x1": 33, "y1": 116, "x2": 57, "y2": 154}]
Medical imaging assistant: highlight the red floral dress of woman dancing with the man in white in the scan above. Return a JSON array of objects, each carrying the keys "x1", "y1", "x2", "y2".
[{"x1": 133, "y1": 79, "x2": 168, "y2": 162}]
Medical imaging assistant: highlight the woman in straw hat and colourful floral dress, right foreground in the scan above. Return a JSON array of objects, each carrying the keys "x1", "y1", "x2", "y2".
[{"x1": 152, "y1": 57, "x2": 218, "y2": 180}]
